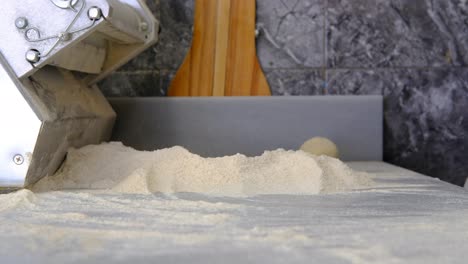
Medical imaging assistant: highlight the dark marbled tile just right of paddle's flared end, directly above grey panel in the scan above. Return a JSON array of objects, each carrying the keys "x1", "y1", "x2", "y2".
[{"x1": 265, "y1": 69, "x2": 325, "y2": 95}]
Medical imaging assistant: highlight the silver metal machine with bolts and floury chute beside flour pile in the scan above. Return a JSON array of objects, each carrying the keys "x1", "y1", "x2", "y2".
[{"x1": 0, "y1": 0, "x2": 159, "y2": 188}]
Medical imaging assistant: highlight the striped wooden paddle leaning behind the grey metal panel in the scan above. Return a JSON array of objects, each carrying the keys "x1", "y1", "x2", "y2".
[{"x1": 169, "y1": 0, "x2": 271, "y2": 96}]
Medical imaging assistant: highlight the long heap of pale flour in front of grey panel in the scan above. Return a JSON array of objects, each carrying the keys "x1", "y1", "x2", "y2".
[{"x1": 32, "y1": 142, "x2": 372, "y2": 197}]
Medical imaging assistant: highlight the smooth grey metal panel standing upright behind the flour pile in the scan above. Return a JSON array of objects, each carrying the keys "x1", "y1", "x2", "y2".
[{"x1": 110, "y1": 96, "x2": 383, "y2": 161}]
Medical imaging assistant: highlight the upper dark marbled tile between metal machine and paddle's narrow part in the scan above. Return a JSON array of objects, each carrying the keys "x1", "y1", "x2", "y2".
[{"x1": 155, "y1": 0, "x2": 195, "y2": 70}]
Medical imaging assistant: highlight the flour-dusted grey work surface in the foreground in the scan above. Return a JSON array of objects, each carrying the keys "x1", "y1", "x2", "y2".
[{"x1": 0, "y1": 162, "x2": 468, "y2": 263}]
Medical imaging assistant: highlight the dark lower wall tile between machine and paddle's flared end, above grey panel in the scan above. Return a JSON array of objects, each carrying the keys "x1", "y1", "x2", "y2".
[{"x1": 98, "y1": 71, "x2": 165, "y2": 97}]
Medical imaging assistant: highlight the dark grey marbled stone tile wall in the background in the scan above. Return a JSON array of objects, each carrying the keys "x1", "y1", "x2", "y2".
[{"x1": 101, "y1": 0, "x2": 468, "y2": 185}]
